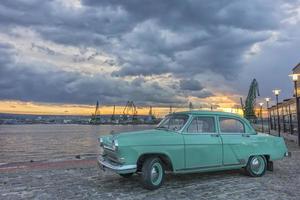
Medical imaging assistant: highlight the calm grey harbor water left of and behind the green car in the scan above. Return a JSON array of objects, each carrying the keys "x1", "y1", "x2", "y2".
[{"x1": 0, "y1": 124, "x2": 154, "y2": 165}]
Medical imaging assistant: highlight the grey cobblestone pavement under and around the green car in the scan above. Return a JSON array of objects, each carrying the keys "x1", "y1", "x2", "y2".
[{"x1": 0, "y1": 142, "x2": 300, "y2": 200}]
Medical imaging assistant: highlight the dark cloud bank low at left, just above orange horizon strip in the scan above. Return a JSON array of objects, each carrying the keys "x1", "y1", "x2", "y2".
[{"x1": 0, "y1": 45, "x2": 185, "y2": 105}]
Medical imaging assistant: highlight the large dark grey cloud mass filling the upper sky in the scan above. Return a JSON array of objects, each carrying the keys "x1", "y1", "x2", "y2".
[{"x1": 0, "y1": 0, "x2": 281, "y2": 78}]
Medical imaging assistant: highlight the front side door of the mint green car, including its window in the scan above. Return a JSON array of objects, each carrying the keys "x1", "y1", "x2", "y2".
[{"x1": 183, "y1": 116, "x2": 222, "y2": 169}]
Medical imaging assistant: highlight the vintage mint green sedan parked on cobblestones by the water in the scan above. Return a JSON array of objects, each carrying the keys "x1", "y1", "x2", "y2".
[{"x1": 98, "y1": 111, "x2": 289, "y2": 190}]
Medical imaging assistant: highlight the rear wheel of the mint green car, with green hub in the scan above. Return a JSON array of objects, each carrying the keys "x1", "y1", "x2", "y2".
[{"x1": 246, "y1": 156, "x2": 267, "y2": 177}]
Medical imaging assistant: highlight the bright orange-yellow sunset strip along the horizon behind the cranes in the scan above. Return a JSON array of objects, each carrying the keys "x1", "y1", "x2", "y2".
[{"x1": 0, "y1": 97, "x2": 242, "y2": 117}]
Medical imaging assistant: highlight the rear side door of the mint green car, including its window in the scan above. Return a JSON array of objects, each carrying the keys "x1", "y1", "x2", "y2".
[{"x1": 218, "y1": 116, "x2": 253, "y2": 166}]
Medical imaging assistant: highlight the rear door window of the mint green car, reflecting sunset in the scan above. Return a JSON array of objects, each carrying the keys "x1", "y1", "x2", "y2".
[{"x1": 219, "y1": 117, "x2": 245, "y2": 133}]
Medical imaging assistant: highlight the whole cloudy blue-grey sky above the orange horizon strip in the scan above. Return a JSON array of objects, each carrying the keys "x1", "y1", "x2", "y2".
[{"x1": 0, "y1": 0, "x2": 300, "y2": 115}]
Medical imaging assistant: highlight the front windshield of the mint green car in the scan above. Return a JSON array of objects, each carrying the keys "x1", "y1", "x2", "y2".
[{"x1": 157, "y1": 114, "x2": 189, "y2": 131}]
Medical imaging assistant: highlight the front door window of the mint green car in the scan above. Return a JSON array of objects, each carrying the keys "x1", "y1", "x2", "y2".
[{"x1": 187, "y1": 117, "x2": 216, "y2": 133}]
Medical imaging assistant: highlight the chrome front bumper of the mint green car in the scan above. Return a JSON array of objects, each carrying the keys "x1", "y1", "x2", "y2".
[{"x1": 97, "y1": 156, "x2": 137, "y2": 174}]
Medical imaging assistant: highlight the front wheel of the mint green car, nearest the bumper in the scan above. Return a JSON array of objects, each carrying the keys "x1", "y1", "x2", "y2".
[{"x1": 141, "y1": 157, "x2": 165, "y2": 190}]
